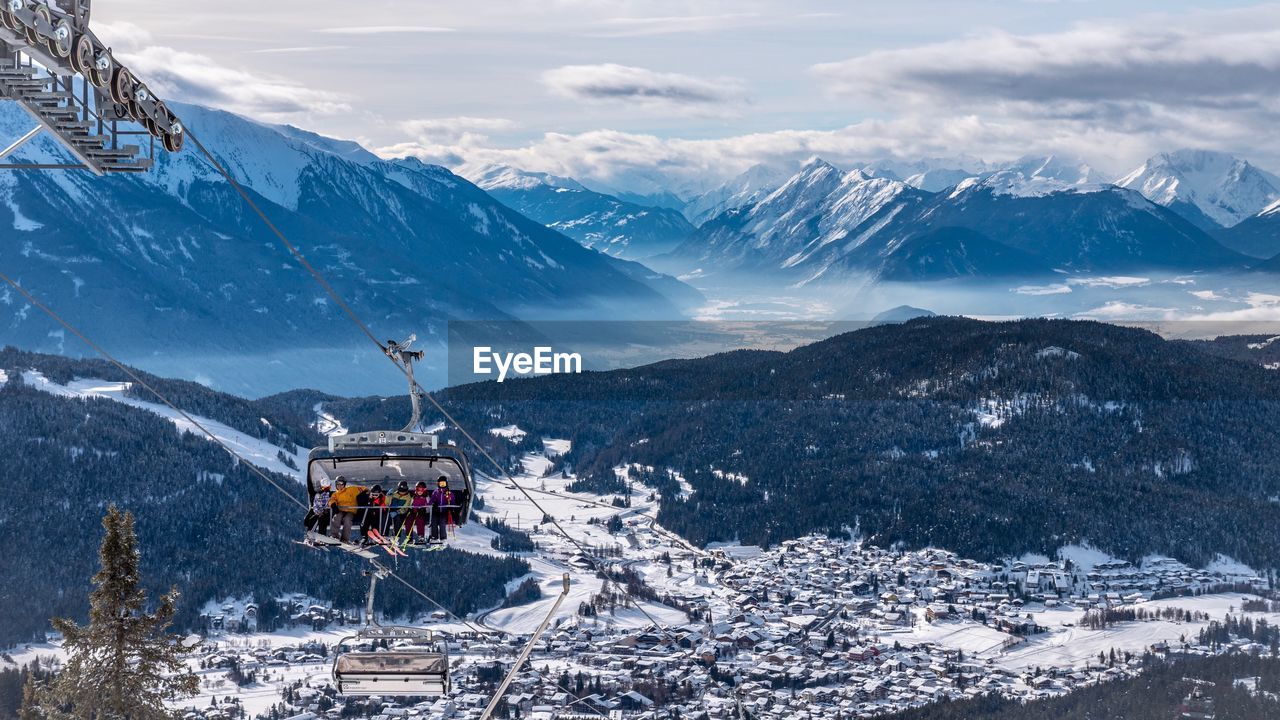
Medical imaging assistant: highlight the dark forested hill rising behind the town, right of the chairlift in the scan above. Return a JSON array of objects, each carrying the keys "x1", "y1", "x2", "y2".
[{"x1": 320, "y1": 318, "x2": 1280, "y2": 569}]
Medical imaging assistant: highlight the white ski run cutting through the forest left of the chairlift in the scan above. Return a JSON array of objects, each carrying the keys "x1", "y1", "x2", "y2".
[{"x1": 22, "y1": 370, "x2": 307, "y2": 482}]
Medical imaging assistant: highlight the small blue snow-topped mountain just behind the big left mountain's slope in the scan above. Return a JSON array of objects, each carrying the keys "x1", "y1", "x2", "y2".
[{"x1": 472, "y1": 165, "x2": 694, "y2": 260}]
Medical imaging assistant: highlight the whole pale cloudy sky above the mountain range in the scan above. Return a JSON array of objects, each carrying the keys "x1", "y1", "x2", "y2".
[{"x1": 93, "y1": 0, "x2": 1280, "y2": 190}]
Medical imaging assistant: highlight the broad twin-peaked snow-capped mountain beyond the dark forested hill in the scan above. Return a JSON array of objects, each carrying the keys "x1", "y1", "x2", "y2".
[{"x1": 660, "y1": 158, "x2": 1247, "y2": 284}]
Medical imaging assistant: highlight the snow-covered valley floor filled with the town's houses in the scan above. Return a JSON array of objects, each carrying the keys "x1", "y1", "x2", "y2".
[{"x1": 0, "y1": 374, "x2": 1280, "y2": 719}]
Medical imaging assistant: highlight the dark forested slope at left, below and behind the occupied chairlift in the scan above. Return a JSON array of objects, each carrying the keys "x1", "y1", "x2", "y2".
[{"x1": 0, "y1": 352, "x2": 527, "y2": 647}]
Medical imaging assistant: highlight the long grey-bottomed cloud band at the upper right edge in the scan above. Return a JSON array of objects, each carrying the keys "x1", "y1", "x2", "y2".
[{"x1": 814, "y1": 18, "x2": 1280, "y2": 113}]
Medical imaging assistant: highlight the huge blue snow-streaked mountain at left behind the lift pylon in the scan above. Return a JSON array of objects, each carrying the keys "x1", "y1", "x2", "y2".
[{"x1": 0, "y1": 104, "x2": 696, "y2": 366}]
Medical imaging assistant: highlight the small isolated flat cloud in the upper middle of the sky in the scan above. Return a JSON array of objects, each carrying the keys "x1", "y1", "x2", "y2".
[{"x1": 543, "y1": 63, "x2": 742, "y2": 114}]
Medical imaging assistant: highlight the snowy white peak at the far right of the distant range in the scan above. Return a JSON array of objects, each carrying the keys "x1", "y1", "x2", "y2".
[{"x1": 1116, "y1": 150, "x2": 1280, "y2": 231}]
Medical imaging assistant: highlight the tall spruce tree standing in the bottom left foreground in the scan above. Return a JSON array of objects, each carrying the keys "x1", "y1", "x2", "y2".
[{"x1": 40, "y1": 505, "x2": 200, "y2": 720}]
